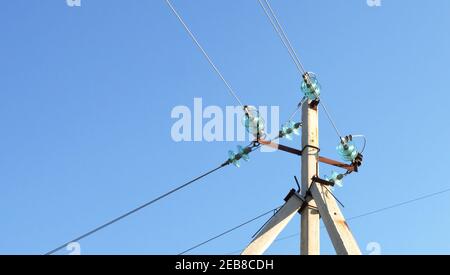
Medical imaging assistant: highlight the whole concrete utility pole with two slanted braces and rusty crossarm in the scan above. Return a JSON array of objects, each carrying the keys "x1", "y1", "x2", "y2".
[{"x1": 241, "y1": 100, "x2": 361, "y2": 255}]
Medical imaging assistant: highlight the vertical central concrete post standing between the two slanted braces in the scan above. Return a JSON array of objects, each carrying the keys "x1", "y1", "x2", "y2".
[{"x1": 300, "y1": 100, "x2": 320, "y2": 255}]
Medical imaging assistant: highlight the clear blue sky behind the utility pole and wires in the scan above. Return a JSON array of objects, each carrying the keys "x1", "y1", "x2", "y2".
[{"x1": 0, "y1": 0, "x2": 450, "y2": 254}]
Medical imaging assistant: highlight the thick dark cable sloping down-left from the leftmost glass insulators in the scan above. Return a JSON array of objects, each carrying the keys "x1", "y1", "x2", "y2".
[{"x1": 45, "y1": 161, "x2": 230, "y2": 255}]
